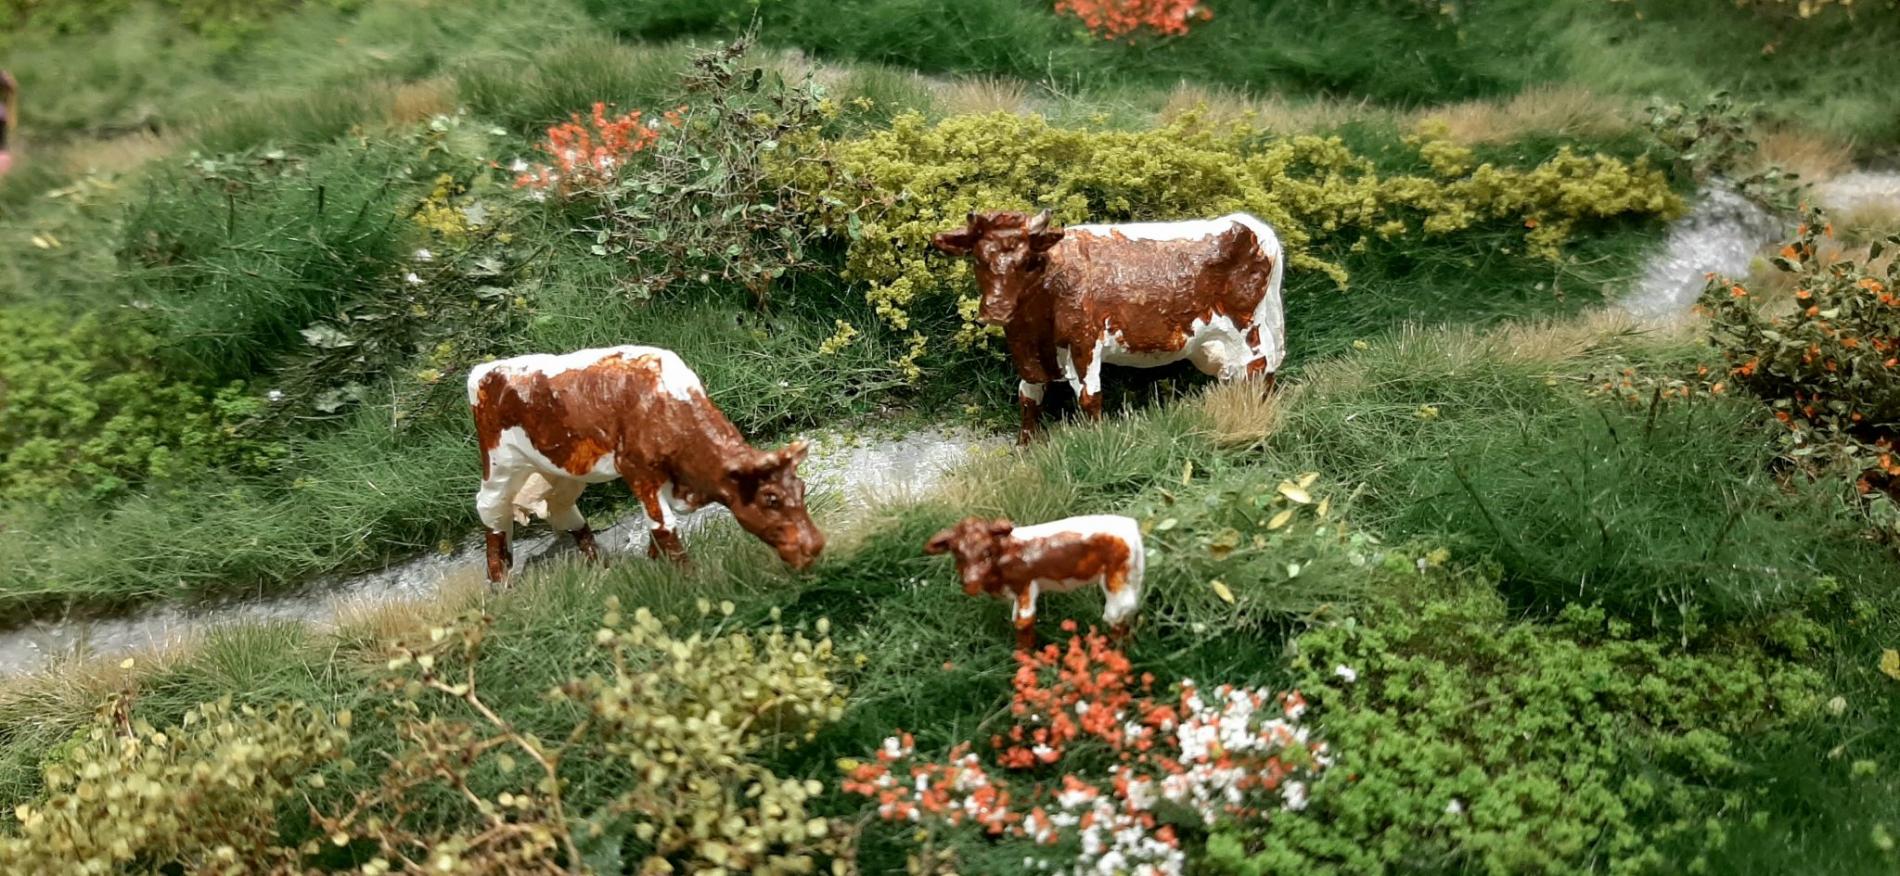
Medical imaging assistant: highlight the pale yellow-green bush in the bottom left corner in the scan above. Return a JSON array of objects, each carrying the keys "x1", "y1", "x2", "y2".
[{"x1": 0, "y1": 697, "x2": 348, "y2": 874}]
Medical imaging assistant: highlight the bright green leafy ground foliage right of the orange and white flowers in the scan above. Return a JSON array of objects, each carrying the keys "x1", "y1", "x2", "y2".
[{"x1": 1208, "y1": 580, "x2": 1826, "y2": 874}]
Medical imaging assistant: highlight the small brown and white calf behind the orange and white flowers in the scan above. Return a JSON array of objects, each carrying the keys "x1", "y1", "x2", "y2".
[{"x1": 923, "y1": 515, "x2": 1146, "y2": 648}]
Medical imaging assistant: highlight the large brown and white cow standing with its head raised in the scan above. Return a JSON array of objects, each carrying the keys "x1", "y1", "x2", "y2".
[{"x1": 931, "y1": 211, "x2": 1286, "y2": 443}]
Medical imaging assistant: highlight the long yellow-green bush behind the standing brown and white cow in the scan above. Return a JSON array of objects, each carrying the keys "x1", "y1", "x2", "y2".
[{"x1": 785, "y1": 112, "x2": 1682, "y2": 374}]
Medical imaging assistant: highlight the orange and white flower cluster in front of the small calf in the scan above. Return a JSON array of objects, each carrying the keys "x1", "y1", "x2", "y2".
[{"x1": 844, "y1": 621, "x2": 1353, "y2": 874}]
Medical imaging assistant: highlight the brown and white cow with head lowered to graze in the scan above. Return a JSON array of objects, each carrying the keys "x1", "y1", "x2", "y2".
[{"x1": 469, "y1": 346, "x2": 825, "y2": 581}]
